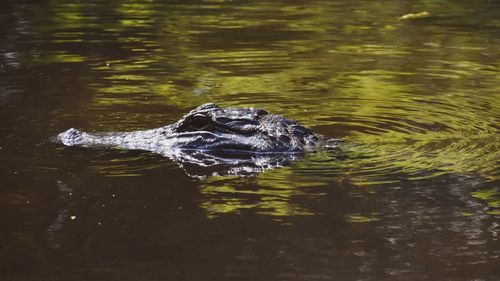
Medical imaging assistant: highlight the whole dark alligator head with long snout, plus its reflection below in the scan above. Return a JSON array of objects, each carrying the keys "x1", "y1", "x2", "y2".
[{"x1": 57, "y1": 103, "x2": 339, "y2": 177}]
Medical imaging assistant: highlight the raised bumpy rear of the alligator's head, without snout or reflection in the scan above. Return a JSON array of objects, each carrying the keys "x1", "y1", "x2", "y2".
[{"x1": 161, "y1": 103, "x2": 320, "y2": 154}]
